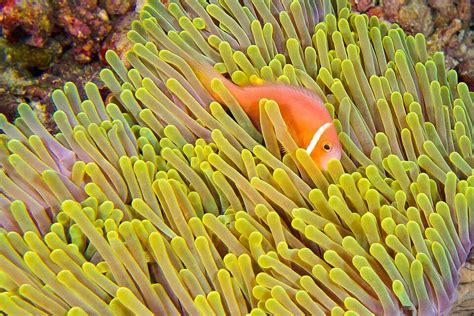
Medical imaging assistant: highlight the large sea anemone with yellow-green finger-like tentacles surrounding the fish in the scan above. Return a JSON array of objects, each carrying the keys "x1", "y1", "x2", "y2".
[{"x1": 0, "y1": 0, "x2": 474, "y2": 315}]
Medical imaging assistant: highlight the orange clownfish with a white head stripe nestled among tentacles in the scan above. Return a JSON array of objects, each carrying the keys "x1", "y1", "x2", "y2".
[{"x1": 189, "y1": 61, "x2": 342, "y2": 170}]
